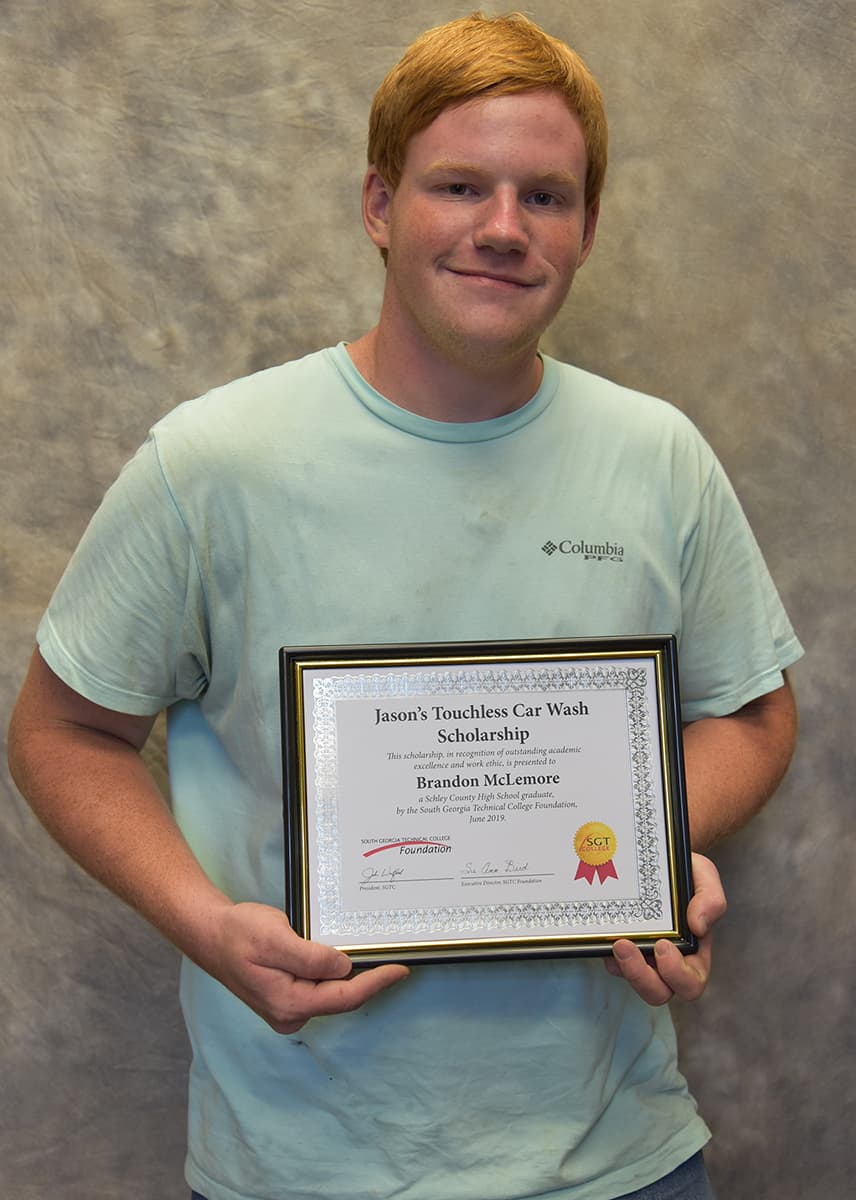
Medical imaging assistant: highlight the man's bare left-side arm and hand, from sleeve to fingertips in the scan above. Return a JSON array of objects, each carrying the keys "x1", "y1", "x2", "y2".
[{"x1": 10, "y1": 652, "x2": 408, "y2": 1033}]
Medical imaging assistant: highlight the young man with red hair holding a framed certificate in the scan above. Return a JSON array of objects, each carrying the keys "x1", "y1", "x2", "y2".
[{"x1": 6, "y1": 16, "x2": 800, "y2": 1200}]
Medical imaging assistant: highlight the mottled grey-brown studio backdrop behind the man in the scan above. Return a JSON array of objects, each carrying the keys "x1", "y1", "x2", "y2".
[{"x1": 0, "y1": 0, "x2": 856, "y2": 1200}]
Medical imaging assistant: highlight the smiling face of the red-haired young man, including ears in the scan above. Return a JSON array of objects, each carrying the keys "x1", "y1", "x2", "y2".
[{"x1": 364, "y1": 91, "x2": 597, "y2": 374}]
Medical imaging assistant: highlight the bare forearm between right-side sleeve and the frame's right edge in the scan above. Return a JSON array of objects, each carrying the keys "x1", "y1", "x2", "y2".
[{"x1": 683, "y1": 683, "x2": 797, "y2": 852}]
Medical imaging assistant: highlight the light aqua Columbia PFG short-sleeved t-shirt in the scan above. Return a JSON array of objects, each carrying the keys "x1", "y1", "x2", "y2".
[{"x1": 38, "y1": 346, "x2": 801, "y2": 1200}]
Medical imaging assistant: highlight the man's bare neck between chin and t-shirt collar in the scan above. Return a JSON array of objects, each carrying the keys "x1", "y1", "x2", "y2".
[{"x1": 348, "y1": 325, "x2": 544, "y2": 422}]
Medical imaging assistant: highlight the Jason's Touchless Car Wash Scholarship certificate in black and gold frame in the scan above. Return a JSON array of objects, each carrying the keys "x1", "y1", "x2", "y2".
[{"x1": 280, "y1": 637, "x2": 695, "y2": 964}]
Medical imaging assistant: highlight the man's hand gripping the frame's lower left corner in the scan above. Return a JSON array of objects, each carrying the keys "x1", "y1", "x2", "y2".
[{"x1": 200, "y1": 904, "x2": 409, "y2": 1033}]
